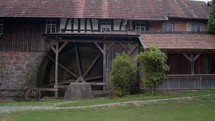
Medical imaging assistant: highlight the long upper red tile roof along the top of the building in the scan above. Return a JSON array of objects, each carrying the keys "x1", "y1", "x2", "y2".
[{"x1": 0, "y1": 0, "x2": 208, "y2": 20}]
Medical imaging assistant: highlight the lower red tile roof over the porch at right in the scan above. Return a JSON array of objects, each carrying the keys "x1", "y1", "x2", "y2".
[{"x1": 141, "y1": 33, "x2": 215, "y2": 50}]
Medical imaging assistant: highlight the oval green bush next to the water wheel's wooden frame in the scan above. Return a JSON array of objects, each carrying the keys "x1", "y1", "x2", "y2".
[{"x1": 110, "y1": 53, "x2": 136, "y2": 96}]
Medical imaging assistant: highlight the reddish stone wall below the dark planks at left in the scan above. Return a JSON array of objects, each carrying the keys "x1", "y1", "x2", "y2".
[{"x1": 0, "y1": 51, "x2": 44, "y2": 100}]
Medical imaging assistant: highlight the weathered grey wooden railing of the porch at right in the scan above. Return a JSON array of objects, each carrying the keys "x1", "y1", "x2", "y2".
[{"x1": 157, "y1": 74, "x2": 215, "y2": 90}]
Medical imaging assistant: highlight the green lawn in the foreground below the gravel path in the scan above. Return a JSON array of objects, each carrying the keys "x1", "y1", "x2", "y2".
[{"x1": 0, "y1": 96, "x2": 215, "y2": 121}]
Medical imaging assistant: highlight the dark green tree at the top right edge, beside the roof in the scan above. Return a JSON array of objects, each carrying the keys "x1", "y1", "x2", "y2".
[{"x1": 208, "y1": 0, "x2": 215, "y2": 34}]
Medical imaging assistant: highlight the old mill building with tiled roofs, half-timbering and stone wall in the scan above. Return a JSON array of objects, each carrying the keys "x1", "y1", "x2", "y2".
[{"x1": 0, "y1": 0, "x2": 215, "y2": 98}]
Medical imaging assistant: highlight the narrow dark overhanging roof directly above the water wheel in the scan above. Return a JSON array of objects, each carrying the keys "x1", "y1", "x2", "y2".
[{"x1": 43, "y1": 32, "x2": 140, "y2": 42}]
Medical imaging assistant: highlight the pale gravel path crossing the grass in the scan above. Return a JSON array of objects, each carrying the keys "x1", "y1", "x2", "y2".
[{"x1": 0, "y1": 94, "x2": 215, "y2": 113}]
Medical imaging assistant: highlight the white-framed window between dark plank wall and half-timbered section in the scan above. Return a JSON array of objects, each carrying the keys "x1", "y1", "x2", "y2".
[{"x1": 46, "y1": 20, "x2": 57, "y2": 34}]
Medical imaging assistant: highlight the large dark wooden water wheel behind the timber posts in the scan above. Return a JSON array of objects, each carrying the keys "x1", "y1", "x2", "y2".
[{"x1": 38, "y1": 43, "x2": 103, "y2": 96}]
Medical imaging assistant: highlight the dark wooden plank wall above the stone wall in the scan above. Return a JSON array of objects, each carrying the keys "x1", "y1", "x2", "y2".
[{"x1": 0, "y1": 18, "x2": 45, "y2": 52}]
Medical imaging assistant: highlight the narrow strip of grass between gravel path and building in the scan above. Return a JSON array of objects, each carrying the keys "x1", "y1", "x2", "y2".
[{"x1": 0, "y1": 90, "x2": 215, "y2": 107}]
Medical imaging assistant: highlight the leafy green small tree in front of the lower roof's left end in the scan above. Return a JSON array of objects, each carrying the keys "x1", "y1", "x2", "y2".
[{"x1": 137, "y1": 46, "x2": 169, "y2": 93}]
